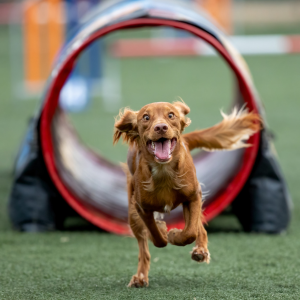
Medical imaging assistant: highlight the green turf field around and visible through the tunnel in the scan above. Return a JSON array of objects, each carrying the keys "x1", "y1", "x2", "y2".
[{"x1": 0, "y1": 27, "x2": 300, "y2": 300}]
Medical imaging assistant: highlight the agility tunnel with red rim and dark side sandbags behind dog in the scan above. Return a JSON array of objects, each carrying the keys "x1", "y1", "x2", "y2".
[{"x1": 9, "y1": 0, "x2": 291, "y2": 235}]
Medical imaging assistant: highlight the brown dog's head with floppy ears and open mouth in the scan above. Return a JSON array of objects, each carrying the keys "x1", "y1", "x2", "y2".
[{"x1": 114, "y1": 102, "x2": 191, "y2": 163}]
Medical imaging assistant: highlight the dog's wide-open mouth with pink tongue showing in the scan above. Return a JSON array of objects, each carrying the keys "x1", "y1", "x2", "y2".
[{"x1": 147, "y1": 138, "x2": 177, "y2": 162}]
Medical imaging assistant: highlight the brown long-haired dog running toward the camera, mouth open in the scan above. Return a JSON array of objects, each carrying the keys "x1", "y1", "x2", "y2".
[{"x1": 114, "y1": 102, "x2": 261, "y2": 287}]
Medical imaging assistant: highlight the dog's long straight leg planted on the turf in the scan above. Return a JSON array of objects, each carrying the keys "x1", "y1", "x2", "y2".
[{"x1": 128, "y1": 198, "x2": 150, "y2": 288}]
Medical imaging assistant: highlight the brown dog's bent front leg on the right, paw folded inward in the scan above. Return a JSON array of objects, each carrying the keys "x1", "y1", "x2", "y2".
[{"x1": 168, "y1": 194, "x2": 201, "y2": 246}]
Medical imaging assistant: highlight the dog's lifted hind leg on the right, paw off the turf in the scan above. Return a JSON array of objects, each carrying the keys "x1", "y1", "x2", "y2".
[{"x1": 191, "y1": 216, "x2": 210, "y2": 263}]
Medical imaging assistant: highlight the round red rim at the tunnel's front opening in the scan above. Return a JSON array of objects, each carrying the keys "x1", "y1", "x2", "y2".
[{"x1": 40, "y1": 18, "x2": 260, "y2": 235}]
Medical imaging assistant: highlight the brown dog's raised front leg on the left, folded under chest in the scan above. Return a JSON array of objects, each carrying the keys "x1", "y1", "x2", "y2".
[{"x1": 135, "y1": 204, "x2": 168, "y2": 248}]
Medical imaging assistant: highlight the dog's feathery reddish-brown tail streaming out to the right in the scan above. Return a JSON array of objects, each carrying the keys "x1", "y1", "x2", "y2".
[{"x1": 183, "y1": 107, "x2": 262, "y2": 151}]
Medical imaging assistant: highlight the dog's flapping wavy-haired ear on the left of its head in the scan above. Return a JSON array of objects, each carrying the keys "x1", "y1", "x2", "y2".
[{"x1": 113, "y1": 108, "x2": 139, "y2": 144}]
